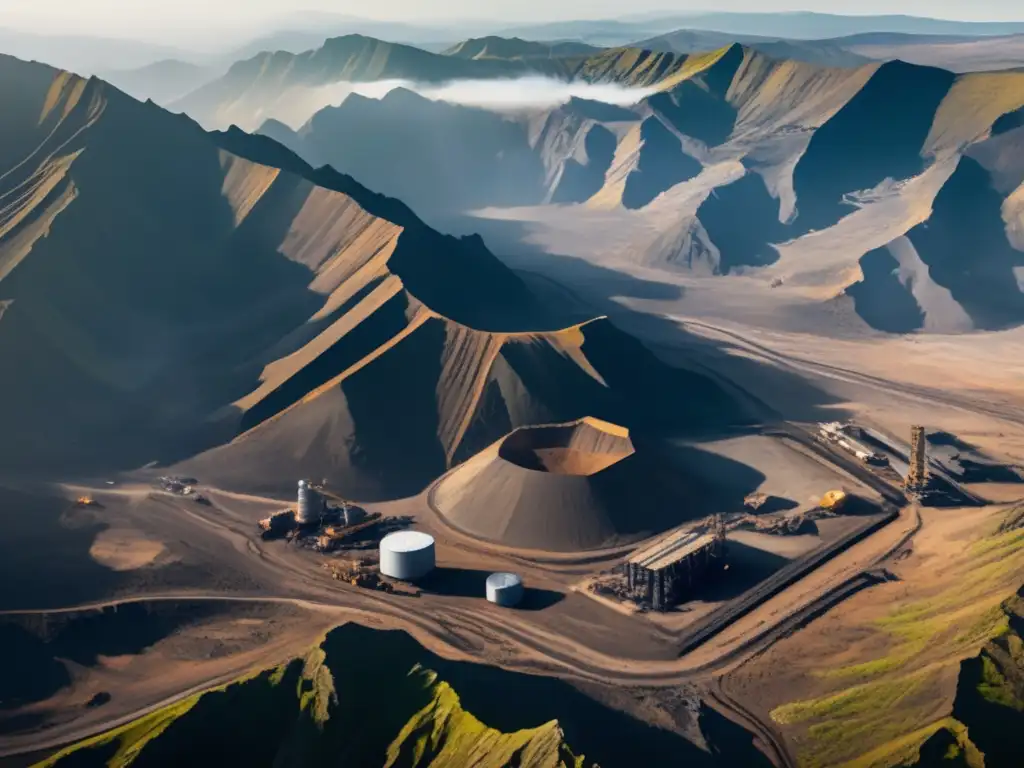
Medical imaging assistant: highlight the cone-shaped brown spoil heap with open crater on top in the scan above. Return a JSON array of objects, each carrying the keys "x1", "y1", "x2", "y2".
[{"x1": 430, "y1": 418, "x2": 702, "y2": 552}]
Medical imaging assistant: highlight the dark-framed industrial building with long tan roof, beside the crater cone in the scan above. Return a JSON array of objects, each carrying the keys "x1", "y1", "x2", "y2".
[{"x1": 623, "y1": 522, "x2": 726, "y2": 610}]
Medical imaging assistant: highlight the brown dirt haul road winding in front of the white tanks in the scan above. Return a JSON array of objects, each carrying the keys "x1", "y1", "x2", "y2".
[{"x1": 0, "y1": 475, "x2": 921, "y2": 767}]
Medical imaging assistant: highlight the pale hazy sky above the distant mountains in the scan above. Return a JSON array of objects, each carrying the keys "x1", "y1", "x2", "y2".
[{"x1": 6, "y1": 0, "x2": 1024, "y2": 36}]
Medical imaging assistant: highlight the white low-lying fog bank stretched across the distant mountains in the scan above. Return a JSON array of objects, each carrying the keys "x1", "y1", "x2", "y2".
[{"x1": 264, "y1": 76, "x2": 656, "y2": 129}]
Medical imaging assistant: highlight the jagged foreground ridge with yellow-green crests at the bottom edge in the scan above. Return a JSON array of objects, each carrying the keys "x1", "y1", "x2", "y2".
[{"x1": 40, "y1": 627, "x2": 593, "y2": 768}]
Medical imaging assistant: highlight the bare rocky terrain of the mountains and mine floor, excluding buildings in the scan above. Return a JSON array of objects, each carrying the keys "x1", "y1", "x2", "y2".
[{"x1": 0, "y1": 25, "x2": 1024, "y2": 768}]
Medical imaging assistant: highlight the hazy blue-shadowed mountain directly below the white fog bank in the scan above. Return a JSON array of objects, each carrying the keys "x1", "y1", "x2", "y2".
[{"x1": 259, "y1": 88, "x2": 637, "y2": 214}]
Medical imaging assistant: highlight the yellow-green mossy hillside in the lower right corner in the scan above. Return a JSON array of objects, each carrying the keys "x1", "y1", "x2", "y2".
[{"x1": 771, "y1": 510, "x2": 1024, "y2": 768}]
